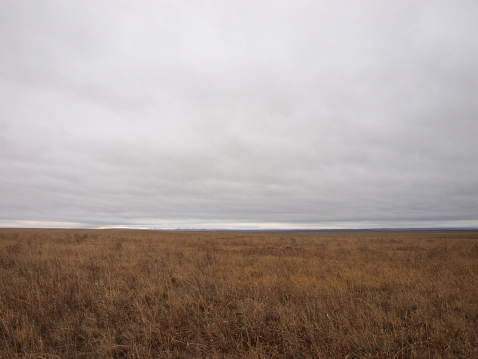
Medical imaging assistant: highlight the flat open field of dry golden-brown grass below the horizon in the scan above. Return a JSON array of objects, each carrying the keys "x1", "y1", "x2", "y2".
[{"x1": 0, "y1": 229, "x2": 478, "y2": 358}]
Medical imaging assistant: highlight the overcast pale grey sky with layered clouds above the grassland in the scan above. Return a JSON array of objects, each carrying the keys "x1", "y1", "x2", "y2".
[{"x1": 0, "y1": 0, "x2": 478, "y2": 229}]
